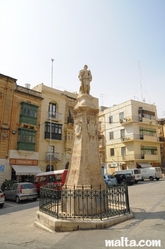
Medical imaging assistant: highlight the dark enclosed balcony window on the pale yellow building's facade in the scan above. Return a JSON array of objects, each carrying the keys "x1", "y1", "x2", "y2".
[{"x1": 45, "y1": 122, "x2": 62, "y2": 140}]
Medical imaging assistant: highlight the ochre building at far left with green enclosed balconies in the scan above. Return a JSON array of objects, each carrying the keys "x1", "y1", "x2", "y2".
[{"x1": 0, "y1": 74, "x2": 42, "y2": 184}]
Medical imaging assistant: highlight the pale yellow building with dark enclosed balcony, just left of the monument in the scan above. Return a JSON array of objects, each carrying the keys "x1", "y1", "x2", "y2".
[{"x1": 33, "y1": 83, "x2": 77, "y2": 171}]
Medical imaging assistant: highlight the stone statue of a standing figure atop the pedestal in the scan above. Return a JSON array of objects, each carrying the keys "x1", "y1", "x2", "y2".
[{"x1": 78, "y1": 65, "x2": 92, "y2": 94}]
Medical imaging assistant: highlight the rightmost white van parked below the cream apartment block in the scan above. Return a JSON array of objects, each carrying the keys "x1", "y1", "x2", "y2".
[{"x1": 140, "y1": 167, "x2": 162, "y2": 181}]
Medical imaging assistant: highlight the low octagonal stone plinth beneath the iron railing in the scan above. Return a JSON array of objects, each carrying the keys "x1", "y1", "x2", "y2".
[{"x1": 34, "y1": 211, "x2": 133, "y2": 232}]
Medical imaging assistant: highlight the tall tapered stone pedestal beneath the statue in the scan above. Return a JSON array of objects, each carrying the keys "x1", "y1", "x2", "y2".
[{"x1": 62, "y1": 94, "x2": 106, "y2": 213}]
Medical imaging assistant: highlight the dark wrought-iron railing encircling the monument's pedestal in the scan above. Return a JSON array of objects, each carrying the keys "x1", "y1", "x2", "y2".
[{"x1": 39, "y1": 185, "x2": 130, "y2": 220}]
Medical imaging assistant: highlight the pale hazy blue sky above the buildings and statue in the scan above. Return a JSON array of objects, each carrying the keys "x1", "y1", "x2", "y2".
[{"x1": 0, "y1": 0, "x2": 165, "y2": 117}]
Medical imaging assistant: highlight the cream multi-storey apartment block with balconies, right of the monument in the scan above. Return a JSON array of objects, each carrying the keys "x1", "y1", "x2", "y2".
[{"x1": 99, "y1": 100, "x2": 163, "y2": 173}]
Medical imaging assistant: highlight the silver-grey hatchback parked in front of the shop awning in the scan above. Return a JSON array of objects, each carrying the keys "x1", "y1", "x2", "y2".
[{"x1": 4, "y1": 182, "x2": 38, "y2": 203}]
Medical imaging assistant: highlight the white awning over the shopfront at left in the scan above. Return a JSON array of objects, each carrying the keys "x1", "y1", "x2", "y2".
[{"x1": 12, "y1": 165, "x2": 42, "y2": 175}]
